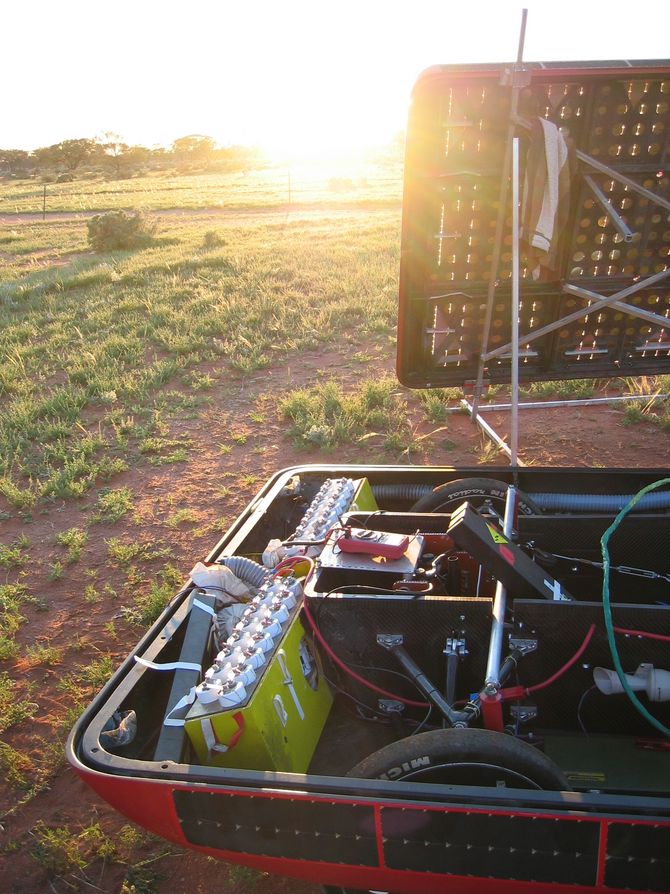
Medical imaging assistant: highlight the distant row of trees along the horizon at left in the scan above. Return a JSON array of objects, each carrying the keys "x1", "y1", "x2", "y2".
[{"x1": 0, "y1": 133, "x2": 263, "y2": 180}]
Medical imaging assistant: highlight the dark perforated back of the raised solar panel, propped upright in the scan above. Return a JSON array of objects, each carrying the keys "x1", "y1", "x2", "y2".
[{"x1": 397, "y1": 62, "x2": 670, "y2": 387}]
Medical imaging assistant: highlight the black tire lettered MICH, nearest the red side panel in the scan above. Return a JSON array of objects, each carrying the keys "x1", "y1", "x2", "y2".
[{"x1": 347, "y1": 729, "x2": 570, "y2": 791}]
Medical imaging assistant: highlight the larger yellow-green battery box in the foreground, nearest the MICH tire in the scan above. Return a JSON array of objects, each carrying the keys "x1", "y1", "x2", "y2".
[{"x1": 185, "y1": 611, "x2": 333, "y2": 773}]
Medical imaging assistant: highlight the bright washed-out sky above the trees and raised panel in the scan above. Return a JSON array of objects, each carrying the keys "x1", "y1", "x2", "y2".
[{"x1": 5, "y1": 0, "x2": 670, "y2": 158}]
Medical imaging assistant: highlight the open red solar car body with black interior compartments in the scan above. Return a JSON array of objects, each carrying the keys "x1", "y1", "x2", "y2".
[{"x1": 68, "y1": 466, "x2": 670, "y2": 892}]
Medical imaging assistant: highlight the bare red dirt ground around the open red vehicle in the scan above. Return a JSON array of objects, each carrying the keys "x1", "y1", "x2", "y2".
[{"x1": 0, "y1": 348, "x2": 670, "y2": 894}]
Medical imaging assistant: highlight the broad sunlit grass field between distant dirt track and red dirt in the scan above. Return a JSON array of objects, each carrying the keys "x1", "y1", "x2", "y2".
[{"x1": 0, "y1": 205, "x2": 398, "y2": 510}]
